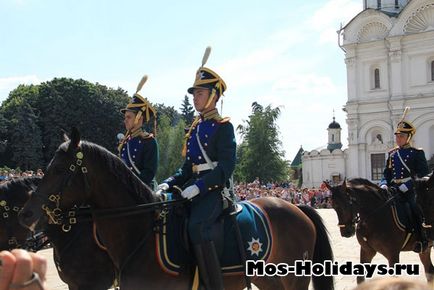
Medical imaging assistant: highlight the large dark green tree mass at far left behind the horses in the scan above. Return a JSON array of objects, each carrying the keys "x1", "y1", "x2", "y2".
[{"x1": 0, "y1": 78, "x2": 129, "y2": 168}]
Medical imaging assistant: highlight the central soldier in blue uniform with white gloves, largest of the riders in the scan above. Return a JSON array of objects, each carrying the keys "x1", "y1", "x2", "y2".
[{"x1": 159, "y1": 48, "x2": 236, "y2": 289}]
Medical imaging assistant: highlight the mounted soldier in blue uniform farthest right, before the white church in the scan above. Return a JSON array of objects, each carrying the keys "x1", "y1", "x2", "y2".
[{"x1": 380, "y1": 108, "x2": 429, "y2": 253}]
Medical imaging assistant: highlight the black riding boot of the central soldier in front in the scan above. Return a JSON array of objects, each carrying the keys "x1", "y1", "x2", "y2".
[{"x1": 194, "y1": 242, "x2": 223, "y2": 290}]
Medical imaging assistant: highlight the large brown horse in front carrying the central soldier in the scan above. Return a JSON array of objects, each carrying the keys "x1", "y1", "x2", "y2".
[{"x1": 20, "y1": 129, "x2": 334, "y2": 290}]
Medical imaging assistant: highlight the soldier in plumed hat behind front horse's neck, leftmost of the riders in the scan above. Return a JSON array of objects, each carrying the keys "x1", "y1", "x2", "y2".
[{"x1": 118, "y1": 76, "x2": 159, "y2": 188}]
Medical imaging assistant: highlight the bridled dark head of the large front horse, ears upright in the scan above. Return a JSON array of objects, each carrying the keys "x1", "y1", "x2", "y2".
[{"x1": 19, "y1": 128, "x2": 87, "y2": 229}]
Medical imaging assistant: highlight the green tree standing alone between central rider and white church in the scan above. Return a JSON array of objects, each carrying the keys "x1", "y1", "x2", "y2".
[{"x1": 236, "y1": 102, "x2": 289, "y2": 182}]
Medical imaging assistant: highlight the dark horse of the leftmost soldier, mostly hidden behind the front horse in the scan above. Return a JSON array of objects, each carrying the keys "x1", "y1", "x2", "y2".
[{"x1": 0, "y1": 177, "x2": 115, "y2": 290}]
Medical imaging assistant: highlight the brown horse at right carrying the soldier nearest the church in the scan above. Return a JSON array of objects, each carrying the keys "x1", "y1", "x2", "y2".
[{"x1": 325, "y1": 178, "x2": 434, "y2": 283}]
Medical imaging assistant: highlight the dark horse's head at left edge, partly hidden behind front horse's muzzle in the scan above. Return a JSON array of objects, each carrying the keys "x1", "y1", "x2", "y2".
[{"x1": 0, "y1": 177, "x2": 40, "y2": 250}]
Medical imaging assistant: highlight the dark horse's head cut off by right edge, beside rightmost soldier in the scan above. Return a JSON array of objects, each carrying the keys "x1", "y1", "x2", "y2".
[{"x1": 414, "y1": 173, "x2": 434, "y2": 236}]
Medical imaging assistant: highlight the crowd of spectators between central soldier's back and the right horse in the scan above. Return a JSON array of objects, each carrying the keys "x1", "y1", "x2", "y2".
[{"x1": 234, "y1": 179, "x2": 331, "y2": 208}]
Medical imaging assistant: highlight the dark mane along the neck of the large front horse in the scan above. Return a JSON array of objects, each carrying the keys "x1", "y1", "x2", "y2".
[{"x1": 58, "y1": 141, "x2": 156, "y2": 203}]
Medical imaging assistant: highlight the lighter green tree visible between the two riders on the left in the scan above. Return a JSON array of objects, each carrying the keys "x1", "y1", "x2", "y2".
[{"x1": 156, "y1": 115, "x2": 185, "y2": 182}]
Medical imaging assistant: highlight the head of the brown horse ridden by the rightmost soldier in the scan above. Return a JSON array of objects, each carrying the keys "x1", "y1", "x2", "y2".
[{"x1": 324, "y1": 180, "x2": 357, "y2": 238}]
